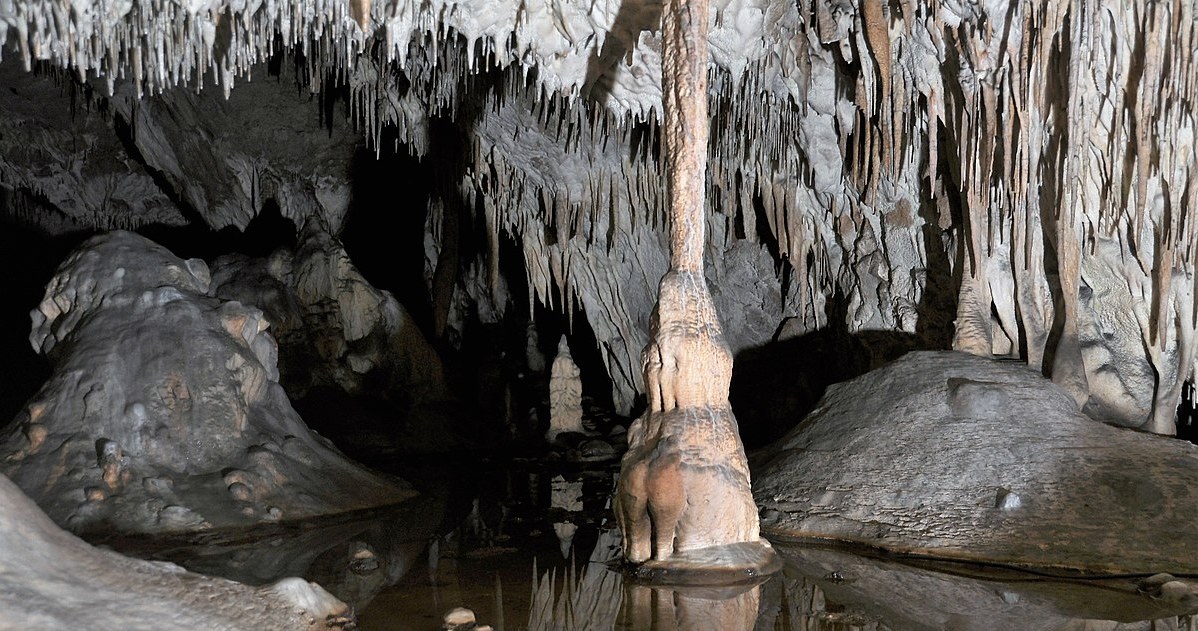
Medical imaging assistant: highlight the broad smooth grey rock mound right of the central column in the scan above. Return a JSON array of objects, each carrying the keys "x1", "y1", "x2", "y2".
[{"x1": 754, "y1": 352, "x2": 1198, "y2": 572}]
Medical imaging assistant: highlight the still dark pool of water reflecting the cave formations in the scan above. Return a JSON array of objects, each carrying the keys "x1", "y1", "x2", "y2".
[{"x1": 86, "y1": 459, "x2": 1198, "y2": 631}]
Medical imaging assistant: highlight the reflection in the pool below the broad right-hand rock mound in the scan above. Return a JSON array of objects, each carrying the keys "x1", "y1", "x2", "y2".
[{"x1": 763, "y1": 546, "x2": 1196, "y2": 631}]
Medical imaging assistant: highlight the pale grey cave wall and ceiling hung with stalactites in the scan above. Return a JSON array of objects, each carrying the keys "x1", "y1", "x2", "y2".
[{"x1": 0, "y1": 0, "x2": 1198, "y2": 432}]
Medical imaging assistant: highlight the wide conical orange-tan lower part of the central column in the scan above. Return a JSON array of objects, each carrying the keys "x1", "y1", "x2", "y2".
[{"x1": 616, "y1": 277, "x2": 781, "y2": 584}]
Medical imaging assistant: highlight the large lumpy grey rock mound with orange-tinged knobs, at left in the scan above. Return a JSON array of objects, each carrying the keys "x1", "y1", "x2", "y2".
[{"x1": 0, "y1": 232, "x2": 412, "y2": 532}]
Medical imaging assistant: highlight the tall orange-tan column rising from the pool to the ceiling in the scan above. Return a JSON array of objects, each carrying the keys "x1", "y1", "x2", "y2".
[{"x1": 615, "y1": 0, "x2": 778, "y2": 581}]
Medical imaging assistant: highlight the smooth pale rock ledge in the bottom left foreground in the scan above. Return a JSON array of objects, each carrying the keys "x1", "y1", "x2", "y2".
[{"x1": 0, "y1": 477, "x2": 349, "y2": 631}]
